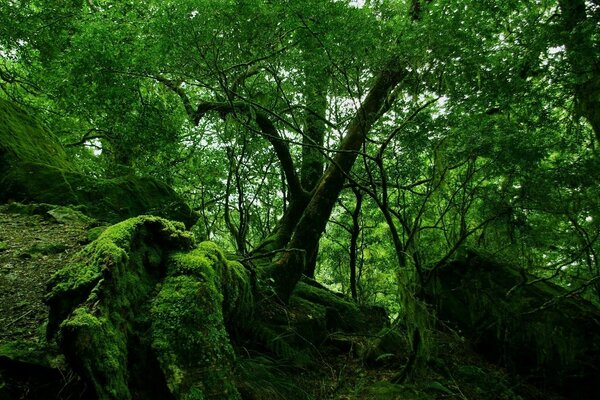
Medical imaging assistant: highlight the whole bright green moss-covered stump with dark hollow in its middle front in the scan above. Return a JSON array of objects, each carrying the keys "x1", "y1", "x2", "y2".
[{"x1": 47, "y1": 217, "x2": 253, "y2": 399}]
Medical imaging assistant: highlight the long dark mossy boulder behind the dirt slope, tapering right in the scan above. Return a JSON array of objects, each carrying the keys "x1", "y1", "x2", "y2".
[{"x1": 0, "y1": 99, "x2": 197, "y2": 227}]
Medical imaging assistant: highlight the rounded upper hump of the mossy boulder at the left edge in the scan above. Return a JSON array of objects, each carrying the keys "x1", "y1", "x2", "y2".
[{"x1": 0, "y1": 98, "x2": 72, "y2": 172}]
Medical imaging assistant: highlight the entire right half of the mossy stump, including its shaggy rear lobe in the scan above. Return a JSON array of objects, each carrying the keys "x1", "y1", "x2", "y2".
[{"x1": 152, "y1": 248, "x2": 253, "y2": 399}]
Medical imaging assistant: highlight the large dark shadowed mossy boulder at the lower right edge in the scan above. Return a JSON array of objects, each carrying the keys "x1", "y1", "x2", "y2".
[{"x1": 427, "y1": 253, "x2": 600, "y2": 399}]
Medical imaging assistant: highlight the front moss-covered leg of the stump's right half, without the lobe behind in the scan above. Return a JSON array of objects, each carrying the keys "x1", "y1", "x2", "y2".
[{"x1": 151, "y1": 275, "x2": 239, "y2": 399}]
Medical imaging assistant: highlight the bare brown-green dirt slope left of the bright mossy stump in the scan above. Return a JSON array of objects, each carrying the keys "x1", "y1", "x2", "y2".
[{"x1": 0, "y1": 206, "x2": 88, "y2": 342}]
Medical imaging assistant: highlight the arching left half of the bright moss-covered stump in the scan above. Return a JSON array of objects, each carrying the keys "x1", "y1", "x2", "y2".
[{"x1": 47, "y1": 217, "x2": 193, "y2": 399}]
